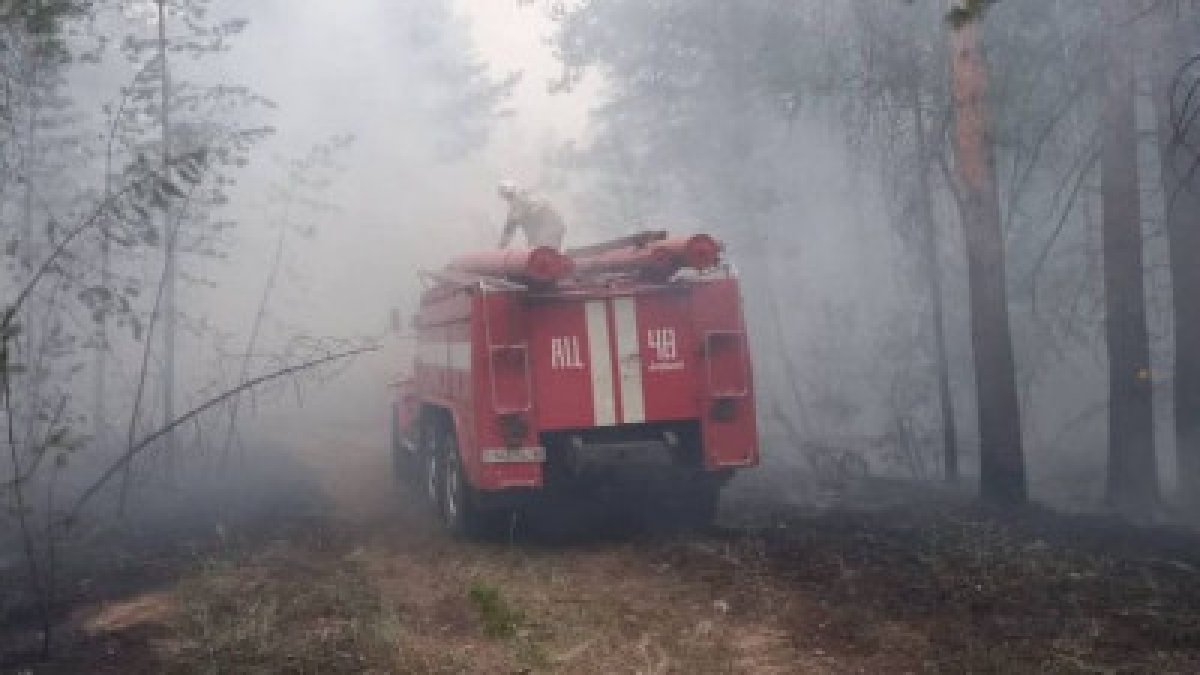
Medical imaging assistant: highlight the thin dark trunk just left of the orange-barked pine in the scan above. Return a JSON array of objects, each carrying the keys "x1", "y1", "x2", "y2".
[{"x1": 912, "y1": 82, "x2": 959, "y2": 483}]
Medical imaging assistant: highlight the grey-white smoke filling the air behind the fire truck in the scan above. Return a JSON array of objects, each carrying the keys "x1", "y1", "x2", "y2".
[{"x1": 7, "y1": 0, "x2": 1190, "y2": 566}]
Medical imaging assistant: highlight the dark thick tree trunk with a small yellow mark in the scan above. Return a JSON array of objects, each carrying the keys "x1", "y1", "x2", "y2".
[{"x1": 1100, "y1": 2, "x2": 1158, "y2": 514}]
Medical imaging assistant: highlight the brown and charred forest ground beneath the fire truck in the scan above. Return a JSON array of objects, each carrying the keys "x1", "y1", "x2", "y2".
[{"x1": 13, "y1": 427, "x2": 1200, "y2": 674}]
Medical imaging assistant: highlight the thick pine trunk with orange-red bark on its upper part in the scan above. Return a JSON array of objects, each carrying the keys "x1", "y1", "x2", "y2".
[{"x1": 950, "y1": 6, "x2": 1028, "y2": 506}]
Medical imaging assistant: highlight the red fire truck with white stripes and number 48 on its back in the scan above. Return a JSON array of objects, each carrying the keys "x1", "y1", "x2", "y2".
[{"x1": 392, "y1": 233, "x2": 758, "y2": 533}]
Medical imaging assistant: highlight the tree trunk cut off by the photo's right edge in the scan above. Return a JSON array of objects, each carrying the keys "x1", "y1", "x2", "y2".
[{"x1": 1150, "y1": 7, "x2": 1200, "y2": 516}]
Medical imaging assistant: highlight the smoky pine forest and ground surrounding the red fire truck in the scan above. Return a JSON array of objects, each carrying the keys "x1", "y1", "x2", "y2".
[{"x1": 0, "y1": 0, "x2": 1200, "y2": 673}]
